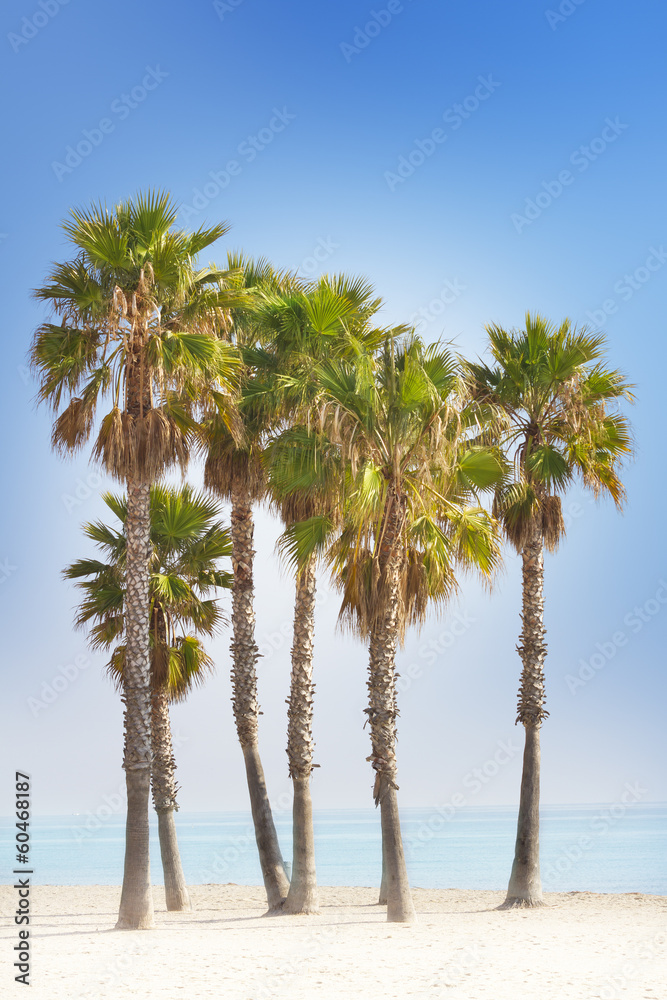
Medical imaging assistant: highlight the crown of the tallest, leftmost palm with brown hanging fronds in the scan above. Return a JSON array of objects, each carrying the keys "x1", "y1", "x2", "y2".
[{"x1": 31, "y1": 192, "x2": 237, "y2": 481}]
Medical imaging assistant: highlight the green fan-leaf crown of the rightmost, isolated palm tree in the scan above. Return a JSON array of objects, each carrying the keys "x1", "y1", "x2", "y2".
[{"x1": 465, "y1": 313, "x2": 633, "y2": 551}]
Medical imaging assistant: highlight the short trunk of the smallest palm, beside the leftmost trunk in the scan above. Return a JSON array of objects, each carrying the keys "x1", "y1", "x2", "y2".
[{"x1": 152, "y1": 687, "x2": 192, "y2": 910}]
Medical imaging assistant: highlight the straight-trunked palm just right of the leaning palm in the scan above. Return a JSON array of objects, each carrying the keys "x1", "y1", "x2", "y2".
[{"x1": 248, "y1": 275, "x2": 392, "y2": 914}]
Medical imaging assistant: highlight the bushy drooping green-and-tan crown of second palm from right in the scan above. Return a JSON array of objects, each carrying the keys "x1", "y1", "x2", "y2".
[{"x1": 310, "y1": 336, "x2": 506, "y2": 638}]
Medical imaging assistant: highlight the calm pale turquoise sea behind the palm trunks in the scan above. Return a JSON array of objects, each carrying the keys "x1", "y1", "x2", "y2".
[{"x1": 0, "y1": 803, "x2": 667, "y2": 895}]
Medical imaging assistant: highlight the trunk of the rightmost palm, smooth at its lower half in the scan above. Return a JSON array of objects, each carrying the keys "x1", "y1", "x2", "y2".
[{"x1": 500, "y1": 522, "x2": 549, "y2": 910}]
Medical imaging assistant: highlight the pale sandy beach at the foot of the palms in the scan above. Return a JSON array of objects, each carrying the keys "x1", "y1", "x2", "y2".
[{"x1": 0, "y1": 885, "x2": 667, "y2": 1000}]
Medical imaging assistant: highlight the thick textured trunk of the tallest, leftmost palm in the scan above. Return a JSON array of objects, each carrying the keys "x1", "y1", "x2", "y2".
[{"x1": 116, "y1": 480, "x2": 154, "y2": 930}]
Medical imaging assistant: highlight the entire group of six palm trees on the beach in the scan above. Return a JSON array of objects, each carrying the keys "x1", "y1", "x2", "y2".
[{"x1": 31, "y1": 192, "x2": 632, "y2": 928}]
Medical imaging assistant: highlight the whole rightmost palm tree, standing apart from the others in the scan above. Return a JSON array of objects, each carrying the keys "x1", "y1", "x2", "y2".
[{"x1": 466, "y1": 313, "x2": 633, "y2": 909}]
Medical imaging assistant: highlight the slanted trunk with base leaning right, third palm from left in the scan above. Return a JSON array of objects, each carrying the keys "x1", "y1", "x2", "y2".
[{"x1": 231, "y1": 487, "x2": 289, "y2": 910}]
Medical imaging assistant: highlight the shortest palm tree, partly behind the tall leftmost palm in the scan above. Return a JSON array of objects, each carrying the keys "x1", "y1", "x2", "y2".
[{"x1": 63, "y1": 486, "x2": 231, "y2": 910}]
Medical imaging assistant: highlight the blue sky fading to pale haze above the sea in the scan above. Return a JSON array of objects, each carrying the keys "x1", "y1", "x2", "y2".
[{"x1": 0, "y1": 0, "x2": 667, "y2": 813}]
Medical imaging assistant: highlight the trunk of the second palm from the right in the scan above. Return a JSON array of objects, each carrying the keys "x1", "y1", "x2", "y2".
[{"x1": 366, "y1": 488, "x2": 415, "y2": 923}]
